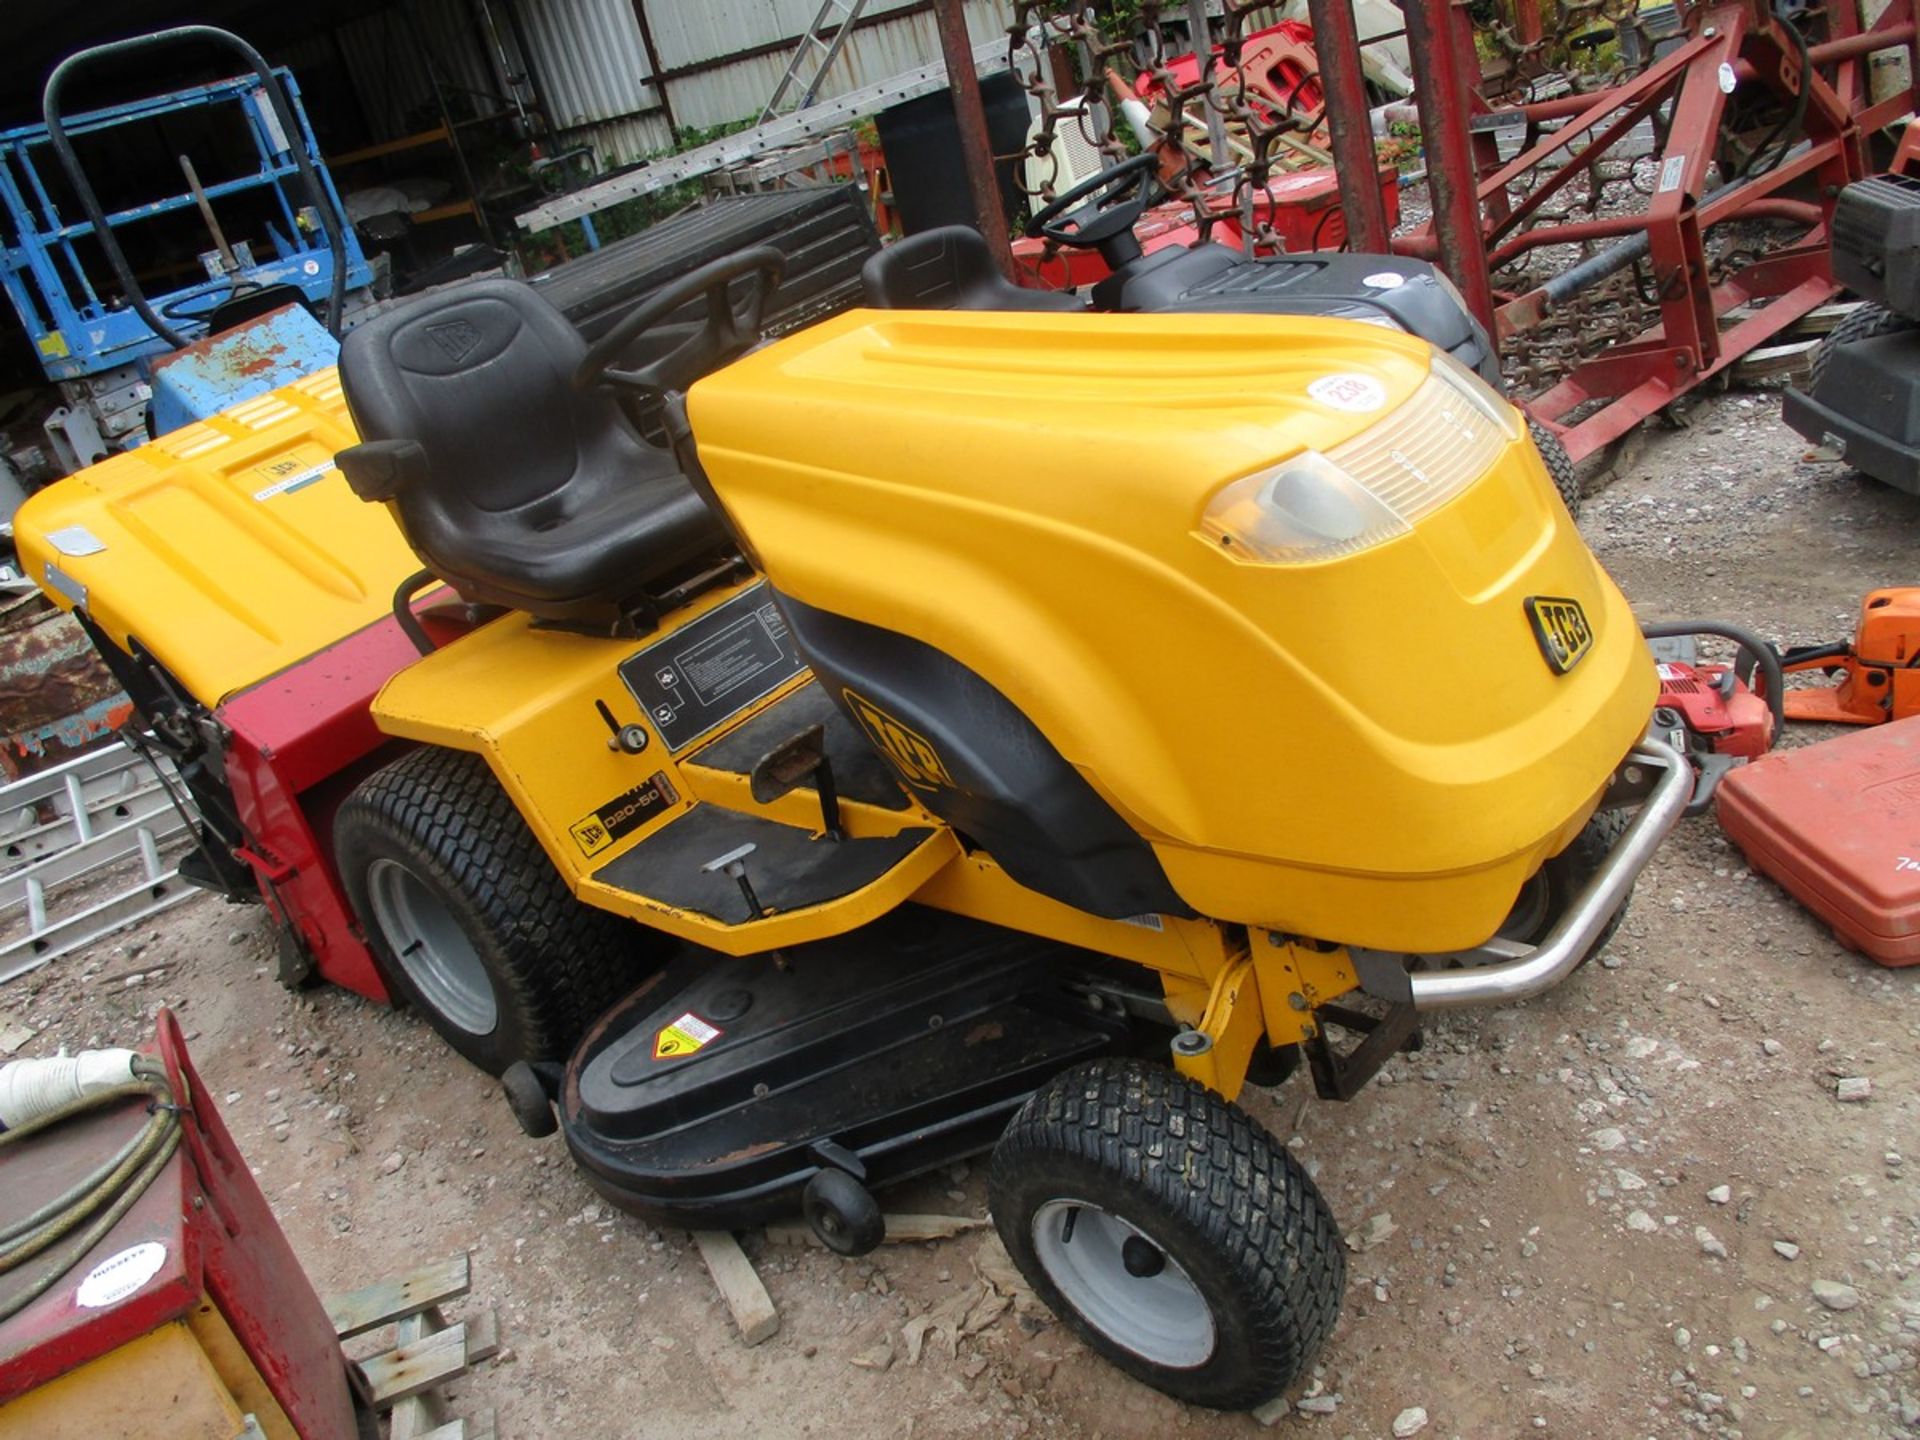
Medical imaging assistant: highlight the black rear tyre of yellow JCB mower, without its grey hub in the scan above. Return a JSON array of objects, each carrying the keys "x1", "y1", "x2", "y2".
[{"x1": 334, "y1": 745, "x2": 666, "y2": 1075}]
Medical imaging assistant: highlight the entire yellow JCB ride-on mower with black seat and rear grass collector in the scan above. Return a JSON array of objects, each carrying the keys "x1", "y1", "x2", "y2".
[{"x1": 19, "y1": 250, "x2": 1692, "y2": 1407}]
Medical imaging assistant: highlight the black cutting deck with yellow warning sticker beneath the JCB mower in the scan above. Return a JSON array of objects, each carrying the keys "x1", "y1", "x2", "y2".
[{"x1": 561, "y1": 906, "x2": 1127, "y2": 1229}]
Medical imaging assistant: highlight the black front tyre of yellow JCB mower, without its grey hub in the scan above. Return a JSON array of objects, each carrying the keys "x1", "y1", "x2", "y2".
[{"x1": 987, "y1": 1058, "x2": 1346, "y2": 1409}]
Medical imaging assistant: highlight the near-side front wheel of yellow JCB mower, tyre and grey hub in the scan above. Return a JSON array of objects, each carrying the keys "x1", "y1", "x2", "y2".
[{"x1": 987, "y1": 1058, "x2": 1346, "y2": 1409}]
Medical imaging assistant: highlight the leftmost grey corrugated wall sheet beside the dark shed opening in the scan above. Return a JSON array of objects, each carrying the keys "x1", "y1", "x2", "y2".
[{"x1": 518, "y1": 0, "x2": 670, "y2": 129}]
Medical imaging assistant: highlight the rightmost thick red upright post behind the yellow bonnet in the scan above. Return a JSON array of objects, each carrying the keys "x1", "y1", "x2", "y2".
[{"x1": 1404, "y1": 0, "x2": 1494, "y2": 336}]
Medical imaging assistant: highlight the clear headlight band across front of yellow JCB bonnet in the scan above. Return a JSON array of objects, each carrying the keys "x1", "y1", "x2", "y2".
[{"x1": 1200, "y1": 351, "x2": 1523, "y2": 564}]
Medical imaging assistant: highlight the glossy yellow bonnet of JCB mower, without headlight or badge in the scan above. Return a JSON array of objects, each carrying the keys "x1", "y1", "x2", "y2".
[{"x1": 689, "y1": 311, "x2": 1657, "y2": 950}]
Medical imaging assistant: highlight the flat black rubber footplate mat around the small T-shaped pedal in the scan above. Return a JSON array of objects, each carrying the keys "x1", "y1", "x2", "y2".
[{"x1": 593, "y1": 804, "x2": 933, "y2": 925}]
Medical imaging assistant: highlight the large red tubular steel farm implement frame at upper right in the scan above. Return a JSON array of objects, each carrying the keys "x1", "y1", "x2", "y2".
[{"x1": 1351, "y1": 0, "x2": 1916, "y2": 459}]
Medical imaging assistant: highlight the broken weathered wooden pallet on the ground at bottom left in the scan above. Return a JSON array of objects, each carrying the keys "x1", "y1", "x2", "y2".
[{"x1": 326, "y1": 1254, "x2": 499, "y2": 1440}]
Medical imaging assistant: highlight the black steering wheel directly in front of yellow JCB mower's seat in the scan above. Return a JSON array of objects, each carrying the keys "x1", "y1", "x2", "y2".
[{"x1": 574, "y1": 246, "x2": 787, "y2": 396}]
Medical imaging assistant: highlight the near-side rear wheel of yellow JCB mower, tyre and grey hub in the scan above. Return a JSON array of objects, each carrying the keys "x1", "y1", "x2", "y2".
[{"x1": 334, "y1": 747, "x2": 666, "y2": 1075}]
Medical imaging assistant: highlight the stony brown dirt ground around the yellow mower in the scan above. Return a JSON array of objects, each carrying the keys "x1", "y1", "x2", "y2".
[{"x1": 0, "y1": 394, "x2": 1920, "y2": 1440}]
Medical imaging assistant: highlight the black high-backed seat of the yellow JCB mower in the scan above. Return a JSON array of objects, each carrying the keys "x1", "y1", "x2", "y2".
[{"x1": 338, "y1": 280, "x2": 728, "y2": 626}]
